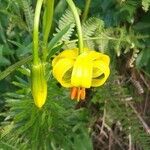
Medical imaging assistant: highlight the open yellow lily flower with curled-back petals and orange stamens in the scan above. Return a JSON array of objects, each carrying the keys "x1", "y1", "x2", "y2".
[{"x1": 52, "y1": 48, "x2": 110, "y2": 100}]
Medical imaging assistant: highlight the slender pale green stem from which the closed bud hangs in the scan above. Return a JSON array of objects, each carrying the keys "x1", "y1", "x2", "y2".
[{"x1": 33, "y1": 0, "x2": 43, "y2": 65}]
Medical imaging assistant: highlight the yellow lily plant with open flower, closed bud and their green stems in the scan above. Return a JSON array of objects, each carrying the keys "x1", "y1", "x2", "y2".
[{"x1": 31, "y1": 0, "x2": 110, "y2": 108}]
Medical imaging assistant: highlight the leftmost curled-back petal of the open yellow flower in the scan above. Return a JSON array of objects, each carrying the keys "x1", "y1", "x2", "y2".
[{"x1": 53, "y1": 58, "x2": 74, "y2": 87}]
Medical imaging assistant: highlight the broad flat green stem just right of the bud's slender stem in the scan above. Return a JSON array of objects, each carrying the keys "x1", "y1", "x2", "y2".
[{"x1": 43, "y1": 0, "x2": 54, "y2": 61}]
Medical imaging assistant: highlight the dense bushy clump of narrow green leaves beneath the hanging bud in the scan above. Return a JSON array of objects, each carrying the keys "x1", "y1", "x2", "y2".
[{"x1": 1, "y1": 69, "x2": 92, "y2": 150}]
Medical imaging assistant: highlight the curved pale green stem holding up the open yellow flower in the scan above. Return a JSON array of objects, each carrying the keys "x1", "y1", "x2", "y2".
[{"x1": 66, "y1": 0, "x2": 84, "y2": 53}]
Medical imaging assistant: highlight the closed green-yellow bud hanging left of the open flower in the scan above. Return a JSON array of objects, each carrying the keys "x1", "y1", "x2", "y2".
[{"x1": 31, "y1": 64, "x2": 47, "y2": 108}]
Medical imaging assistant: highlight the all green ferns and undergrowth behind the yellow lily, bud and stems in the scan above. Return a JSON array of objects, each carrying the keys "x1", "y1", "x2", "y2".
[{"x1": 0, "y1": 0, "x2": 150, "y2": 150}]
